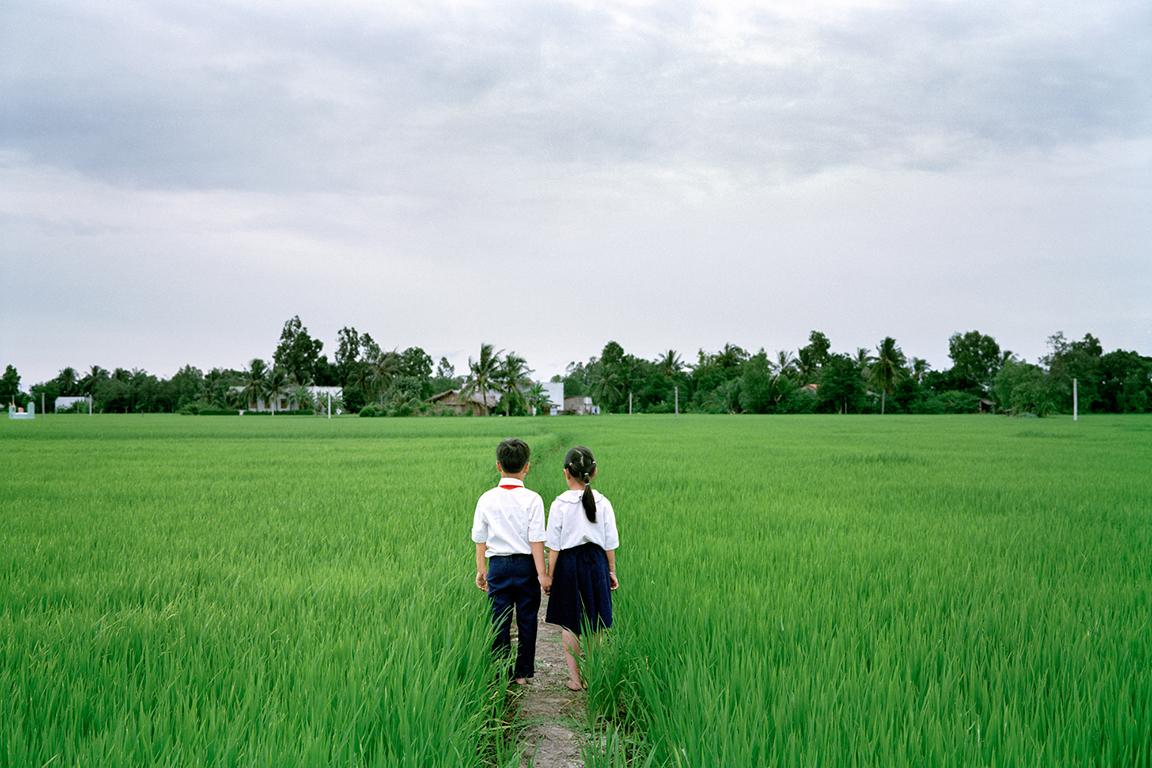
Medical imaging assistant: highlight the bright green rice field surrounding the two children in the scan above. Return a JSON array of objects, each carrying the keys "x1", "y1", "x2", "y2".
[{"x1": 0, "y1": 416, "x2": 1152, "y2": 767}]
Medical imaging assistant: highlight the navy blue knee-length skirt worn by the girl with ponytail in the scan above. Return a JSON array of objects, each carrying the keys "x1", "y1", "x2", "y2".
[{"x1": 545, "y1": 543, "x2": 612, "y2": 634}]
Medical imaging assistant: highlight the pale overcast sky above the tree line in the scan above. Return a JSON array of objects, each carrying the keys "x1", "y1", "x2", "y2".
[{"x1": 0, "y1": 0, "x2": 1152, "y2": 388}]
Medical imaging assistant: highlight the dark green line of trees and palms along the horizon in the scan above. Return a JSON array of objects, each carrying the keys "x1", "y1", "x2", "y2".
[{"x1": 0, "y1": 317, "x2": 1152, "y2": 416}]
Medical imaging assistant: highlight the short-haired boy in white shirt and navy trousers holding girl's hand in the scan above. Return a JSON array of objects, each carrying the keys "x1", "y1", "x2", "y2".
[{"x1": 472, "y1": 438, "x2": 550, "y2": 685}]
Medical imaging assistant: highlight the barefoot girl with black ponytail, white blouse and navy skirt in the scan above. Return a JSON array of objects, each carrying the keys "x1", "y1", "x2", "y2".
[{"x1": 545, "y1": 446, "x2": 620, "y2": 691}]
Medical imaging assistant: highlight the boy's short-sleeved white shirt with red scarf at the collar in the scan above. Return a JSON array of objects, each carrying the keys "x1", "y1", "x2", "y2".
[{"x1": 472, "y1": 478, "x2": 545, "y2": 557}]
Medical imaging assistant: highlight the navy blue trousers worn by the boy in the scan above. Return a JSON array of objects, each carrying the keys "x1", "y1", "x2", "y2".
[{"x1": 488, "y1": 555, "x2": 540, "y2": 678}]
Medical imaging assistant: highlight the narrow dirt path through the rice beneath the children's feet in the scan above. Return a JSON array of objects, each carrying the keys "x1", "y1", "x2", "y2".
[{"x1": 520, "y1": 596, "x2": 588, "y2": 768}]
